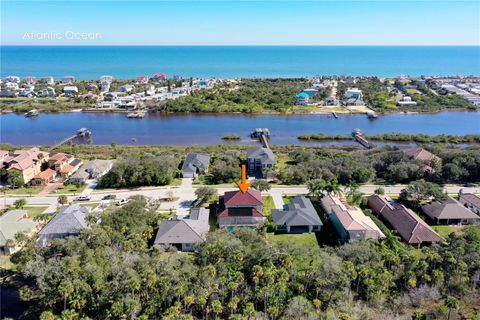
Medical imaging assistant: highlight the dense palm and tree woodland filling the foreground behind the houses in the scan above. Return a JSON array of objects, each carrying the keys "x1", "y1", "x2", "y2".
[{"x1": 6, "y1": 197, "x2": 480, "y2": 320}]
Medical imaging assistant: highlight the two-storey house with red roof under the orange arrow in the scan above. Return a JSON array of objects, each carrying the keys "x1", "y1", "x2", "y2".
[{"x1": 218, "y1": 189, "x2": 265, "y2": 231}]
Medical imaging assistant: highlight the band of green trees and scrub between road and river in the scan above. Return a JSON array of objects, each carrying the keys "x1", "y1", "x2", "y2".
[{"x1": 4, "y1": 141, "x2": 480, "y2": 187}]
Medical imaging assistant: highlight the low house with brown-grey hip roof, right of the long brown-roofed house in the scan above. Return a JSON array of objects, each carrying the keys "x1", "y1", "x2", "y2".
[{"x1": 422, "y1": 197, "x2": 480, "y2": 224}]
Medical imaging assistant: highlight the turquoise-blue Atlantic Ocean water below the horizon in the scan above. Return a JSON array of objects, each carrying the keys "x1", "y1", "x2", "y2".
[{"x1": 0, "y1": 46, "x2": 480, "y2": 79}]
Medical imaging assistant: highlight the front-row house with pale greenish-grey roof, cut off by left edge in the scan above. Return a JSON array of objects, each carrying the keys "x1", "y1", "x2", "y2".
[{"x1": 0, "y1": 210, "x2": 40, "y2": 255}]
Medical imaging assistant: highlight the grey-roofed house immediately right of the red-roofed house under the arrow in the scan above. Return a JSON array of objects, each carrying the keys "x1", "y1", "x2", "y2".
[{"x1": 272, "y1": 197, "x2": 323, "y2": 233}]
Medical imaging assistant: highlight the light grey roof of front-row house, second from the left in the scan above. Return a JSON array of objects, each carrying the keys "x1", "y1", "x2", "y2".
[{"x1": 38, "y1": 204, "x2": 90, "y2": 235}]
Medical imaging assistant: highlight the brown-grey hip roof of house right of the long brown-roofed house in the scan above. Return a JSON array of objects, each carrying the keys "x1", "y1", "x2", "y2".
[{"x1": 422, "y1": 197, "x2": 480, "y2": 220}]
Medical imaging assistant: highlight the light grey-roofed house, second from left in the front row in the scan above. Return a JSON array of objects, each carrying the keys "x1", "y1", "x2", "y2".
[{"x1": 37, "y1": 204, "x2": 91, "y2": 247}]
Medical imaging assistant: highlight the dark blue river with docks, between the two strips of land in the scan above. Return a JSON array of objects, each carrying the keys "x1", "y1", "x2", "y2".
[{"x1": 0, "y1": 112, "x2": 480, "y2": 145}]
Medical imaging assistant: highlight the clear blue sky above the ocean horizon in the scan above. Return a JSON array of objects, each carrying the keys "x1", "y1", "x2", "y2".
[{"x1": 1, "y1": 0, "x2": 480, "y2": 45}]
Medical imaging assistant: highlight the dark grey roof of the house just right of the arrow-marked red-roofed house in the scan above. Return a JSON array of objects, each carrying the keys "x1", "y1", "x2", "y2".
[{"x1": 272, "y1": 197, "x2": 323, "y2": 226}]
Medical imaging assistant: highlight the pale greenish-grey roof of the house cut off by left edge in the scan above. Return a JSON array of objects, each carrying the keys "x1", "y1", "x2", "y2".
[{"x1": 0, "y1": 210, "x2": 39, "y2": 246}]
